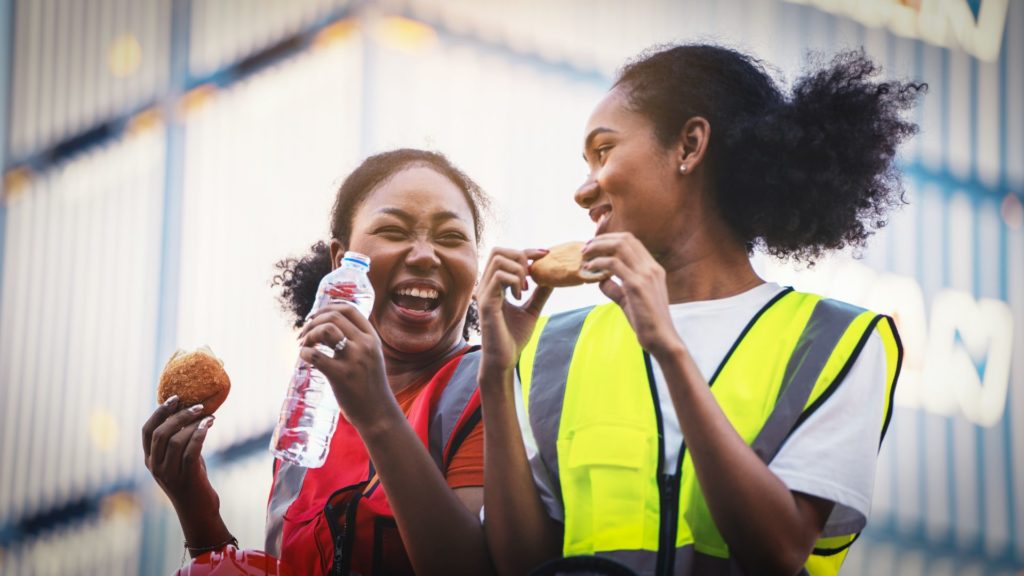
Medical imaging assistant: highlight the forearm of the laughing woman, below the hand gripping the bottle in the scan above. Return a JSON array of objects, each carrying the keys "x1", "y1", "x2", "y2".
[{"x1": 359, "y1": 393, "x2": 494, "y2": 575}]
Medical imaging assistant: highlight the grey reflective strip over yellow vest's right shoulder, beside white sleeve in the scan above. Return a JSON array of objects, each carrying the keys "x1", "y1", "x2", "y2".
[{"x1": 751, "y1": 299, "x2": 864, "y2": 463}]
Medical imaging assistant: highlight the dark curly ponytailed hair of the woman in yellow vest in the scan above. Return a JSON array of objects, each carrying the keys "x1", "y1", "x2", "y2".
[{"x1": 614, "y1": 44, "x2": 928, "y2": 263}]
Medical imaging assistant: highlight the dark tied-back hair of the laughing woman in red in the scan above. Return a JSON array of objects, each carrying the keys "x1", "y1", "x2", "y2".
[{"x1": 270, "y1": 149, "x2": 490, "y2": 338}]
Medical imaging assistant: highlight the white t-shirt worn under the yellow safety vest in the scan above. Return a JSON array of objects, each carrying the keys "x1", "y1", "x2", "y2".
[{"x1": 515, "y1": 283, "x2": 886, "y2": 536}]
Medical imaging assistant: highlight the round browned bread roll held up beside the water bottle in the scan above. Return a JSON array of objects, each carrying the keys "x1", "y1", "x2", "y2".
[{"x1": 157, "y1": 346, "x2": 231, "y2": 414}]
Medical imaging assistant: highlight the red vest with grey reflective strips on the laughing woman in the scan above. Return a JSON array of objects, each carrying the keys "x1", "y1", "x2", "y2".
[{"x1": 266, "y1": 348, "x2": 480, "y2": 576}]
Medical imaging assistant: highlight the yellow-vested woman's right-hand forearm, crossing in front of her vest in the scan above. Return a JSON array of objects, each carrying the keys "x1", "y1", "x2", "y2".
[{"x1": 656, "y1": 343, "x2": 823, "y2": 574}]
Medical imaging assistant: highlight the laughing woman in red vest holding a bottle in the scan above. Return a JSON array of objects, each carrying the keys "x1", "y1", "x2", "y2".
[{"x1": 142, "y1": 150, "x2": 492, "y2": 574}]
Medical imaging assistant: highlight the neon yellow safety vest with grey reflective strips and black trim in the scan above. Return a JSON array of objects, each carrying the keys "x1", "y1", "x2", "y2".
[{"x1": 519, "y1": 291, "x2": 901, "y2": 575}]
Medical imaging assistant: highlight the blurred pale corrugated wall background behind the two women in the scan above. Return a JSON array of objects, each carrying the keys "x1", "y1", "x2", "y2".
[{"x1": 0, "y1": 0, "x2": 1024, "y2": 575}]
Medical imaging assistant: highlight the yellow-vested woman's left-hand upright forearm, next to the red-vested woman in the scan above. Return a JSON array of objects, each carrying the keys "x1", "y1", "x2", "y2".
[{"x1": 480, "y1": 362, "x2": 561, "y2": 574}]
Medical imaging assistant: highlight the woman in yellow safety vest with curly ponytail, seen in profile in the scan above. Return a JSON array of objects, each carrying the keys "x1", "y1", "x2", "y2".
[{"x1": 477, "y1": 45, "x2": 925, "y2": 575}]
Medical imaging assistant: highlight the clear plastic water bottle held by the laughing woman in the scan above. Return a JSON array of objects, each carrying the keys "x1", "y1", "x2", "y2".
[{"x1": 270, "y1": 252, "x2": 374, "y2": 468}]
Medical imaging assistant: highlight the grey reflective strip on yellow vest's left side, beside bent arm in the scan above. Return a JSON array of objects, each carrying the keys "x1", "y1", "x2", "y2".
[{"x1": 527, "y1": 306, "x2": 594, "y2": 501}]
